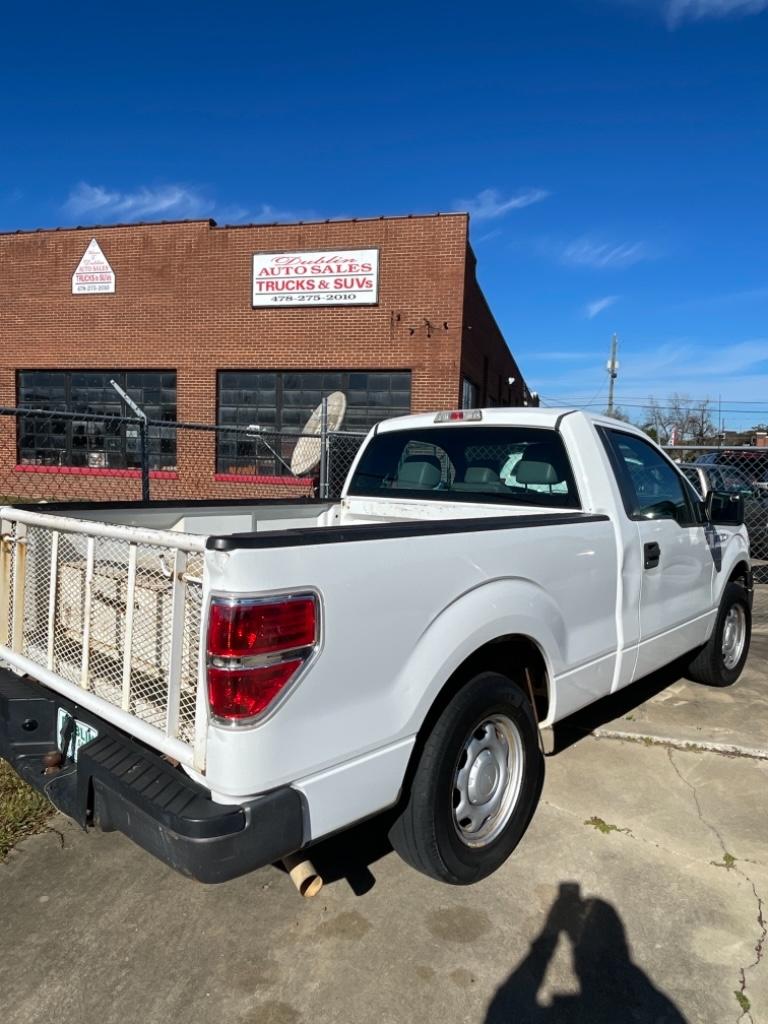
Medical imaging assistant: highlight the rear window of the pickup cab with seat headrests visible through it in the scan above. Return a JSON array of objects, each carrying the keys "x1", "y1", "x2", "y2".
[{"x1": 348, "y1": 426, "x2": 580, "y2": 509}]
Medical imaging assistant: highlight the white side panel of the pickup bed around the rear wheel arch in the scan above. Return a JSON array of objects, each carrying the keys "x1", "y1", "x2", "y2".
[{"x1": 199, "y1": 517, "x2": 616, "y2": 811}]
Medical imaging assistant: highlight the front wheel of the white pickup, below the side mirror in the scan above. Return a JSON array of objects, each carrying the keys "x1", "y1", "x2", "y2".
[{"x1": 686, "y1": 583, "x2": 752, "y2": 686}]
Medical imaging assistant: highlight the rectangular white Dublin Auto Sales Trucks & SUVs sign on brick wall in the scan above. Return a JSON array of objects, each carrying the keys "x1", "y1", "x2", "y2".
[{"x1": 253, "y1": 249, "x2": 379, "y2": 307}]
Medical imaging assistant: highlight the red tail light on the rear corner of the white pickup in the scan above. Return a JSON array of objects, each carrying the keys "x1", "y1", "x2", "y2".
[{"x1": 207, "y1": 594, "x2": 319, "y2": 722}]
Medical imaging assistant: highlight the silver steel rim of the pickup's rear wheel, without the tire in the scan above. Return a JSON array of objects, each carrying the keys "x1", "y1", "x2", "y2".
[{"x1": 452, "y1": 714, "x2": 524, "y2": 848}]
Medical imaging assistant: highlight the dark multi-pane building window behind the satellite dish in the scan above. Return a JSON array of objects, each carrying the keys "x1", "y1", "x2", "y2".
[{"x1": 217, "y1": 370, "x2": 411, "y2": 473}]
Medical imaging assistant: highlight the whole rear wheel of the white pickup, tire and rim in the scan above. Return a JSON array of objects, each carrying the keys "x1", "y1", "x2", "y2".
[{"x1": 390, "y1": 672, "x2": 544, "y2": 885}]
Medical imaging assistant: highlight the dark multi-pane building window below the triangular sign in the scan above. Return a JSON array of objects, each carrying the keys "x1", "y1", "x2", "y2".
[{"x1": 18, "y1": 370, "x2": 176, "y2": 469}]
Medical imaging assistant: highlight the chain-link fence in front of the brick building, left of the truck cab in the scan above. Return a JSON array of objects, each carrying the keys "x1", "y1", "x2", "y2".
[{"x1": 0, "y1": 407, "x2": 366, "y2": 504}]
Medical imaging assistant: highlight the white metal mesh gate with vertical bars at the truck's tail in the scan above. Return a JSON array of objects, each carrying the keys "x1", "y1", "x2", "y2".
[{"x1": 0, "y1": 507, "x2": 207, "y2": 771}]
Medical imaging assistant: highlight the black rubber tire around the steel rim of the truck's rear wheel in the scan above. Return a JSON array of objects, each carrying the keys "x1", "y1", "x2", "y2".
[{"x1": 389, "y1": 672, "x2": 544, "y2": 885}]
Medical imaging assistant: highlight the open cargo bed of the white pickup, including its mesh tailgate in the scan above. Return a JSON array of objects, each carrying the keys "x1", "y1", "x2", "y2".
[{"x1": 0, "y1": 500, "x2": 602, "y2": 771}]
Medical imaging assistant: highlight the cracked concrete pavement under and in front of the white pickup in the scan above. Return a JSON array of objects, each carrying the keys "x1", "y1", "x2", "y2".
[{"x1": 0, "y1": 589, "x2": 768, "y2": 1024}]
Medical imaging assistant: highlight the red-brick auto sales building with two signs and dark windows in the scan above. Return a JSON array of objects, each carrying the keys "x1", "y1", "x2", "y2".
[{"x1": 0, "y1": 214, "x2": 530, "y2": 497}]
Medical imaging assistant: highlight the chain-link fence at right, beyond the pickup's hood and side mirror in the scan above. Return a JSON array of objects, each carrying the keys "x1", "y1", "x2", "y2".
[{"x1": 666, "y1": 444, "x2": 768, "y2": 583}]
